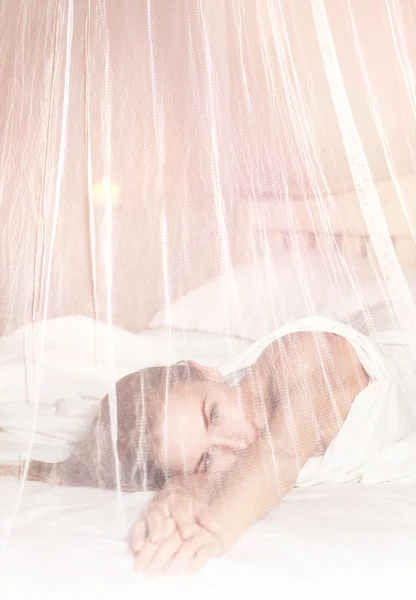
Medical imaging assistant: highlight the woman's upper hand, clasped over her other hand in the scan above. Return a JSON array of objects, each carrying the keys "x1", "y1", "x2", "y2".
[{"x1": 131, "y1": 485, "x2": 218, "y2": 554}]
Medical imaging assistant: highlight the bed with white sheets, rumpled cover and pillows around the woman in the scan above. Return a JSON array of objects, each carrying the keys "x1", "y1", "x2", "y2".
[{"x1": 0, "y1": 185, "x2": 416, "y2": 600}]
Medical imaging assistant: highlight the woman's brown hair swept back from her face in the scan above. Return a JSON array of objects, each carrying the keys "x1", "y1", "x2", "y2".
[{"x1": 58, "y1": 362, "x2": 205, "y2": 492}]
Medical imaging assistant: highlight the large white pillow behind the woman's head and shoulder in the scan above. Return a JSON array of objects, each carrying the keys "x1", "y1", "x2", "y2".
[{"x1": 150, "y1": 251, "x2": 380, "y2": 341}]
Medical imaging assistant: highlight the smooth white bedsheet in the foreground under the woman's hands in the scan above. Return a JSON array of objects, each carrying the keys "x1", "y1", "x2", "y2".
[{"x1": 0, "y1": 480, "x2": 416, "y2": 600}]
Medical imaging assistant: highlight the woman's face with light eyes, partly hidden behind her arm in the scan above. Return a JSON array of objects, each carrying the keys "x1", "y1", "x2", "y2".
[{"x1": 160, "y1": 380, "x2": 258, "y2": 474}]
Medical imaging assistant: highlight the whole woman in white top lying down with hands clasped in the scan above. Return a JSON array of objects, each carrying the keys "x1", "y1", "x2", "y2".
[{"x1": 3, "y1": 318, "x2": 416, "y2": 575}]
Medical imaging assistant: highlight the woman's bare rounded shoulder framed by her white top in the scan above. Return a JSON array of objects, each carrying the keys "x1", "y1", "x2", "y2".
[{"x1": 273, "y1": 332, "x2": 368, "y2": 459}]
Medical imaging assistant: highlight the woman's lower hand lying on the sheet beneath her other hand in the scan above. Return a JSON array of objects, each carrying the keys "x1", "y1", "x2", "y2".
[{"x1": 134, "y1": 526, "x2": 227, "y2": 577}]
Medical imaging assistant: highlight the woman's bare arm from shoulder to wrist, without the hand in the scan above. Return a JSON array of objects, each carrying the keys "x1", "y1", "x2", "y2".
[{"x1": 206, "y1": 333, "x2": 368, "y2": 547}]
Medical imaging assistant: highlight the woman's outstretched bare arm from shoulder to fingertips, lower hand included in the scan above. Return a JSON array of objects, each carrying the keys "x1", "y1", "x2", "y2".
[{"x1": 132, "y1": 333, "x2": 368, "y2": 574}]
